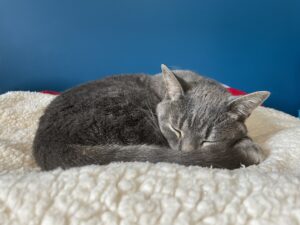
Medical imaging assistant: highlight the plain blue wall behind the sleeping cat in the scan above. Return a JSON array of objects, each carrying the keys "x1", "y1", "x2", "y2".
[{"x1": 0, "y1": 0, "x2": 300, "y2": 115}]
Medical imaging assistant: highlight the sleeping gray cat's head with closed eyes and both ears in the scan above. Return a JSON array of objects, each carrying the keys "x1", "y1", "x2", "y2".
[{"x1": 156, "y1": 65, "x2": 270, "y2": 152}]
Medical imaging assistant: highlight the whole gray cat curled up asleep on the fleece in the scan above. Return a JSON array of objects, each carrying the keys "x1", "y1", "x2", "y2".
[{"x1": 33, "y1": 65, "x2": 269, "y2": 170}]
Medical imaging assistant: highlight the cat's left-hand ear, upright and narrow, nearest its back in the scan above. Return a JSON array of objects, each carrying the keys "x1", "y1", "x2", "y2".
[{"x1": 161, "y1": 64, "x2": 183, "y2": 100}]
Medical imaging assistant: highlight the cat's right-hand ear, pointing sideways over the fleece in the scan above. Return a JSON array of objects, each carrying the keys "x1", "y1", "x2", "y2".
[{"x1": 229, "y1": 91, "x2": 270, "y2": 119}]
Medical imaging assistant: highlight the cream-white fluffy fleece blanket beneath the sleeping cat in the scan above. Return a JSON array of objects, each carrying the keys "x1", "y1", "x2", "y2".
[{"x1": 0, "y1": 92, "x2": 300, "y2": 225}]
